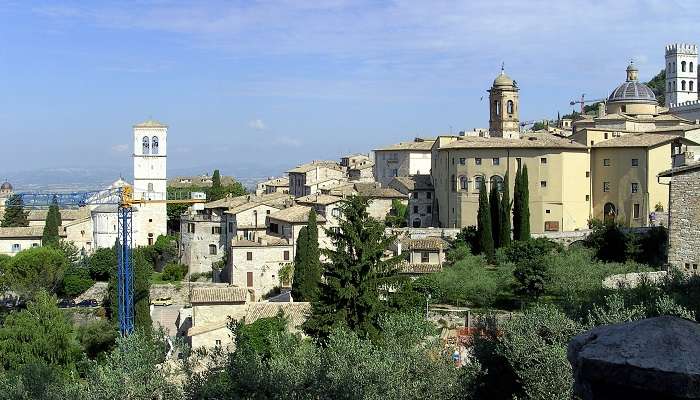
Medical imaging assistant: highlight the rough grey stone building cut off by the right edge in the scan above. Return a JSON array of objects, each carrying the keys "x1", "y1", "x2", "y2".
[{"x1": 659, "y1": 163, "x2": 700, "y2": 274}]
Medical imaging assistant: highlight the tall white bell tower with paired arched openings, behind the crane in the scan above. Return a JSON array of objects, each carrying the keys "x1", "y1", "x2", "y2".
[{"x1": 133, "y1": 120, "x2": 168, "y2": 246}]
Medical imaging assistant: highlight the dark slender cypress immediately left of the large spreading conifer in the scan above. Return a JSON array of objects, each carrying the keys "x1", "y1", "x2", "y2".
[{"x1": 292, "y1": 209, "x2": 321, "y2": 302}]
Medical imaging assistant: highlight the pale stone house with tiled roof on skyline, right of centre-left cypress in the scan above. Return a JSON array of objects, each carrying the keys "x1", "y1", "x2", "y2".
[{"x1": 287, "y1": 161, "x2": 347, "y2": 197}]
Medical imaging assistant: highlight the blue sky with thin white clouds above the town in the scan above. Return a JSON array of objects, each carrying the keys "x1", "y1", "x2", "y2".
[{"x1": 0, "y1": 0, "x2": 700, "y2": 179}]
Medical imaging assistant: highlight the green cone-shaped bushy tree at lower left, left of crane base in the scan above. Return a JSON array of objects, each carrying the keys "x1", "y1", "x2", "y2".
[{"x1": 0, "y1": 290, "x2": 81, "y2": 370}]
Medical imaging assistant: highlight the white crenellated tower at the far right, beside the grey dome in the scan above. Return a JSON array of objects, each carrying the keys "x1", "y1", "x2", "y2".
[{"x1": 665, "y1": 43, "x2": 698, "y2": 107}]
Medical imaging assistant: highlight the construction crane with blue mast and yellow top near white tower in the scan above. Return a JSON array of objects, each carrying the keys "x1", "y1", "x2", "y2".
[{"x1": 6, "y1": 186, "x2": 206, "y2": 335}]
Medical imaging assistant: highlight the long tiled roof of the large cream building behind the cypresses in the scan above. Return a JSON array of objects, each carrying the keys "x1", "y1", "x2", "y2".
[{"x1": 439, "y1": 133, "x2": 586, "y2": 150}]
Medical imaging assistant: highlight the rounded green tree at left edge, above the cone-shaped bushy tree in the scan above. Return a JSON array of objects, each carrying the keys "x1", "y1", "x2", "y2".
[{"x1": 5, "y1": 247, "x2": 68, "y2": 298}]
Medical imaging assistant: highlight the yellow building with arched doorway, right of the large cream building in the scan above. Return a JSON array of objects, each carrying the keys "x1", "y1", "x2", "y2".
[{"x1": 590, "y1": 133, "x2": 697, "y2": 227}]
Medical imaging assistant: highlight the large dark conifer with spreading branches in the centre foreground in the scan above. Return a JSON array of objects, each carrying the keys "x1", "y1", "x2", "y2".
[{"x1": 303, "y1": 196, "x2": 402, "y2": 340}]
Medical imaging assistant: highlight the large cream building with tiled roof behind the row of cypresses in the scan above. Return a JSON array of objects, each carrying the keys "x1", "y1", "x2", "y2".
[{"x1": 432, "y1": 133, "x2": 590, "y2": 233}]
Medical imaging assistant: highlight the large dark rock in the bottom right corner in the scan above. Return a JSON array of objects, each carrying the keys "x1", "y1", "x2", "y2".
[{"x1": 568, "y1": 317, "x2": 700, "y2": 400}]
